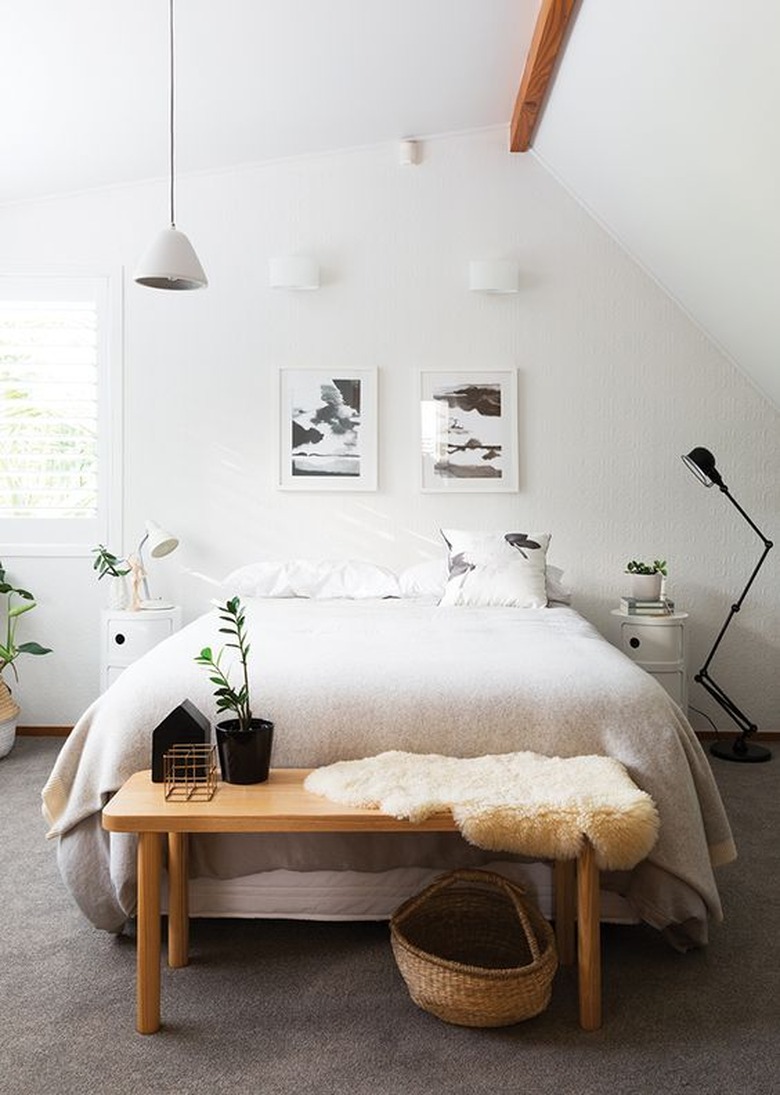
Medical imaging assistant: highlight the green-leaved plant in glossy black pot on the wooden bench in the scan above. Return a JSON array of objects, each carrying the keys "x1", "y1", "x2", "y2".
[{"x1": 195, "y1": 597, "x2": 274, "y2": 783}]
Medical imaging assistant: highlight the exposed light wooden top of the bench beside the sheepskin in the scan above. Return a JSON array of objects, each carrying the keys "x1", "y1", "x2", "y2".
[{"x1": 103, "y1": 768, "x2": 457, "y2": 832}]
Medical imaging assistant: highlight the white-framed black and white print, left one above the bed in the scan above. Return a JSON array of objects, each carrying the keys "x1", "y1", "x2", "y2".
[{"x1": 278, "y1": 369, "x2": 377, "y2": 491}]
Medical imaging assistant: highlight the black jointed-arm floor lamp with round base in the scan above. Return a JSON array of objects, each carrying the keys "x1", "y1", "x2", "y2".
[{"x1": 683, "y1": 449, "x2": 772, "y2": 763}]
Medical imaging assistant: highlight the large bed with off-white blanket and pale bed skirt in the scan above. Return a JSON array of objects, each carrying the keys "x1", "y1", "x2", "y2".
[{"x1": 43, "y1": 545, "x2": 735, "y2": 948}]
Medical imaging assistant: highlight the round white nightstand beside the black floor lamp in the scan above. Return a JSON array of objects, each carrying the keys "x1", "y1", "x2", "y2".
[{"x1": 612, "y1": 609, "x2": 688, "y2": 714}]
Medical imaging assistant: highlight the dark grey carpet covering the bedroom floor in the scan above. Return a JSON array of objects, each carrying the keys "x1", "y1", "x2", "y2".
[{"x1": 0, "y1": 738, "x2": 780, "y2": 1095}]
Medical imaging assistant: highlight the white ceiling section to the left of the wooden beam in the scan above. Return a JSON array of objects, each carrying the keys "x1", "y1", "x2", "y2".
[{"x1": 0, "y1": 0, "x2": 539, "y2": 201}]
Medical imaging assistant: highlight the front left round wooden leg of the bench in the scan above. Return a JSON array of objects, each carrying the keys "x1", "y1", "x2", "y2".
[{"x1": 136, "y1": 832, "x2": 162, "y2": 1034}]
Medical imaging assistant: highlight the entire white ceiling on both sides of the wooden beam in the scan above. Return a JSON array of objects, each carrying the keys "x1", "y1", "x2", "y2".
[{"x1": 0, "y1": 0, "x2": 780, "y2": 407}]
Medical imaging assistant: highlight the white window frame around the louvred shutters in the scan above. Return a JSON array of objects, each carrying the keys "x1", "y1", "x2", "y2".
[{"x1": 0, "y1": 267, "x2": 124, "y2": 558}]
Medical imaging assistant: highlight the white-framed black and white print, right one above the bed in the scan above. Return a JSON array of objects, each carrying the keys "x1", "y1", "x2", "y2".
[{"x1": 420, "y1": 369, "x2": 518, "y2": 493}]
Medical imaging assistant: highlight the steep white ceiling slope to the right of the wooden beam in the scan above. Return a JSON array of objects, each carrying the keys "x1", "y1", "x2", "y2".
[{"x1": 534, "y1": 0, "x2": 780, "y2": 407}]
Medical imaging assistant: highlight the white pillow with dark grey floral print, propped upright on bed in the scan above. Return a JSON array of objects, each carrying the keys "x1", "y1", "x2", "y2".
[{"x1": 439, "y1": 529, "x2": 550, "y2": 609}]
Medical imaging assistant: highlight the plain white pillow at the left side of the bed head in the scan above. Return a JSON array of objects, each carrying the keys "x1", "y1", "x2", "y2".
[{"x1": 222, "y1": 558, "x2": 401, "y2": 600}]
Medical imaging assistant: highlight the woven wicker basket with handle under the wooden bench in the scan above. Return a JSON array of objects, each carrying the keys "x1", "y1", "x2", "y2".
[{"x1": 390, "y1": 871, "x2": 558, "y2": 1027}]
